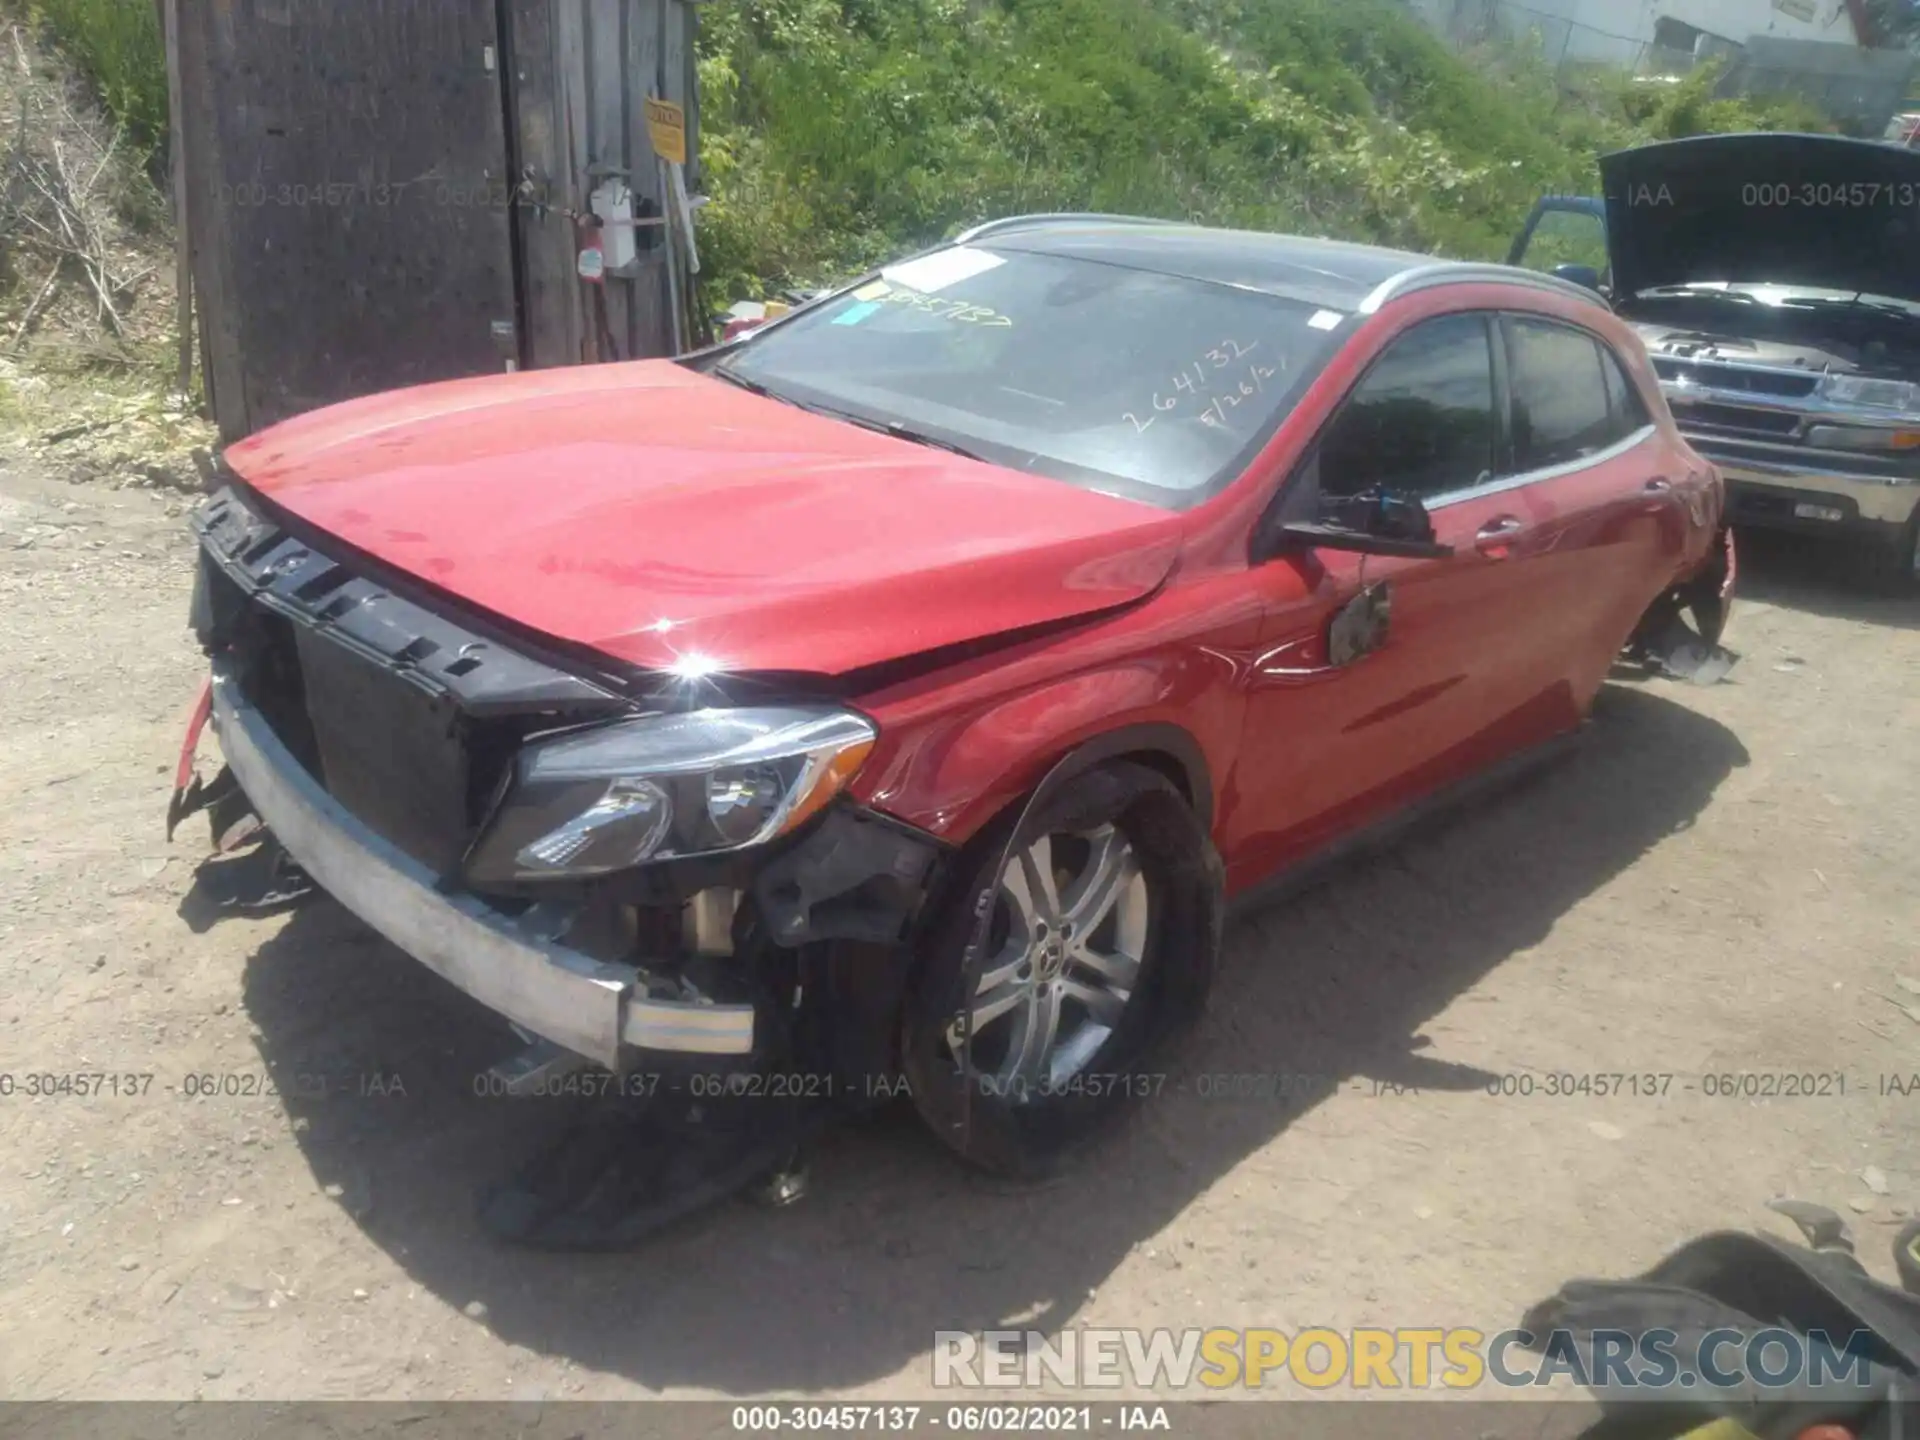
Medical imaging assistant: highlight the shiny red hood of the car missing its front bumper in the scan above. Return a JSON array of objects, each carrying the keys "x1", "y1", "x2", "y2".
[{"x1": 227, "y1": 361, "x2": 1181, "y2": 674}]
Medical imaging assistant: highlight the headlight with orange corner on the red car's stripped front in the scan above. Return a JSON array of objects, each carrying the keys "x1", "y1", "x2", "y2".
[{"x1": 467, "y1": 707, "x2": 876, "y2": 885}]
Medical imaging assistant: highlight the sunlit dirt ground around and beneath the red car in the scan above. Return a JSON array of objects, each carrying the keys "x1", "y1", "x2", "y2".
[{"x1": 0, "y1": 470, "x2": 1920, "y2": 1398}]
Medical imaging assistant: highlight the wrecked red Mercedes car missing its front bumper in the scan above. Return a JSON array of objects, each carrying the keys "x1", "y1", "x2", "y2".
[{"x1": 175, "y1": 217, "x2": 1732, "y2": 1198}]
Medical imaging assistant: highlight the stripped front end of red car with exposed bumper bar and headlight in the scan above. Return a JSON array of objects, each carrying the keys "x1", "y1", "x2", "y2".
[{"x1": 167, "y1": 490, "x2": 943, "y2": 1244}]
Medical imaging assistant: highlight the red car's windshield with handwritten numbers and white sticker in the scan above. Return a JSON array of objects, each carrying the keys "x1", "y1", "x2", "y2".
[{"x1": 716, "y1": 246, "x2": 1346, "y2": 507}]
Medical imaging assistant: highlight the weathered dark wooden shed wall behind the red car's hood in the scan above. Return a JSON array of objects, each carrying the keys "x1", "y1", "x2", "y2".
[{"x1": 169, "y1": 0, "x2": 697, "y2": 440}]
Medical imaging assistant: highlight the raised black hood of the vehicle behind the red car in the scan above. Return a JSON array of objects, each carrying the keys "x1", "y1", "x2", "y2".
[{"x1": 1599, "y1": 134, "x2": 1920, "y2": 300}]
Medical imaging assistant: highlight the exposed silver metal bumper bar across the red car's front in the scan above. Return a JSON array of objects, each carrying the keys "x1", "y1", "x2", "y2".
[{"x1": 213, "y1": 664, "x2": 755, "y2": 1071}]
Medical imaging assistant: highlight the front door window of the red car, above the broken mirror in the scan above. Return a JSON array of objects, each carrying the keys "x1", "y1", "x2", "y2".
[{"x1": 1319, "y1": 315, "x2": 1496, "y2": 499}]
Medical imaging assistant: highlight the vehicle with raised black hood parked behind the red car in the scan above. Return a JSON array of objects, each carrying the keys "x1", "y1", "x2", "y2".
[{"x1": 1509, "y1": 134, "x2": 1920, "y2": 588}]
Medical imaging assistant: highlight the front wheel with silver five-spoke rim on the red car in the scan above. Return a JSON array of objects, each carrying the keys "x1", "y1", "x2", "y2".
[{"x1": 900, "y1": 762, "x2": 1225, "y2": 1177}]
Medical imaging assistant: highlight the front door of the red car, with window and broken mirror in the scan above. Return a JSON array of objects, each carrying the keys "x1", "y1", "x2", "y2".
[{"x1": 1223, "y1": 313, "x2": 1549, "y2": 889}]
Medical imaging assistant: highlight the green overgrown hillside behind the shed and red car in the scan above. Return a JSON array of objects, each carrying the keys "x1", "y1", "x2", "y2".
[{"x1": 11, "y1": 0, "x2": 1822, "y2": 303}]
